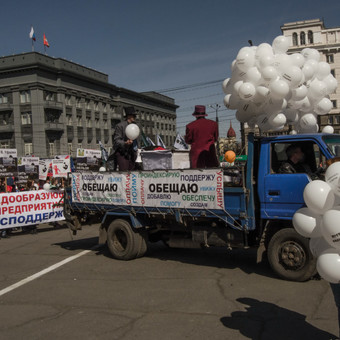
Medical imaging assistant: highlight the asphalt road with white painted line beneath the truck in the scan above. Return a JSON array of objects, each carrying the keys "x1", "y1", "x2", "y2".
[{"x1": 0, "y1": 225, "x2": 338, "y2": 340}]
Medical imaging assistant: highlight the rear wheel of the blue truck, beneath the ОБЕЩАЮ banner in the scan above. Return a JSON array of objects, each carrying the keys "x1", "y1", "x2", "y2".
[{"x1": 107, "y1": 219, "x2": 146, "y2": 261}]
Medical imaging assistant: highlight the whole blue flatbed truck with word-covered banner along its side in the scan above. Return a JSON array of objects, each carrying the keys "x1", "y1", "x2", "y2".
[{"x1": 64, "y1": 133, "x2": 340, "y2": 281}]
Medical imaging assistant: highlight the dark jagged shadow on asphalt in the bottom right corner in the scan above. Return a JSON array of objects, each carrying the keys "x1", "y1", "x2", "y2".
[{"x1": 220, "y1": 297, "x2": 335, "y2": 340}]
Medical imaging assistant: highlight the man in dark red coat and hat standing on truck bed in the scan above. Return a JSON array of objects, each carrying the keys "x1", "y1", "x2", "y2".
[{"x1": 185, "y1": 105, "x2": 219, "y2": 169}]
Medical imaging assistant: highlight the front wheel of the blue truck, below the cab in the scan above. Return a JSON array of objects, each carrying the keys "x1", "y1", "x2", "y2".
[{"x1": 268, "y1": 228, "x2": 316, "y2": 282}]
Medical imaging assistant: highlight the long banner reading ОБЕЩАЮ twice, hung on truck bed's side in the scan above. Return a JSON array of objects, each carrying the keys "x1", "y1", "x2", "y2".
[{"x1": 71, "y1": 169, "x2": 224, "y2": 209}]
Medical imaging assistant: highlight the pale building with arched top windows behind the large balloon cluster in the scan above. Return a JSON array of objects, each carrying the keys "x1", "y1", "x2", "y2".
[{"x1": 281, "y1": 19, "x2": 340, "y2": 133}]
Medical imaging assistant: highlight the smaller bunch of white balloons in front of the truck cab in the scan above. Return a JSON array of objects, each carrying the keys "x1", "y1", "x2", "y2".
[{"x1": 293, "y1": 162, "x2": 340, "y2": 283}]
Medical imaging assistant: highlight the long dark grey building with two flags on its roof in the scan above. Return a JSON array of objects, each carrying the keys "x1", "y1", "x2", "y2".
[{"x1": 0, "y1": 52, "x2": 177, "y2": 158}]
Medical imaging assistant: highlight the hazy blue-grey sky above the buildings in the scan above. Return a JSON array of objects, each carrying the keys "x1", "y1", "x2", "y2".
[{"x1": 0, "y1": 0, "x2": 340, "y2": 138}]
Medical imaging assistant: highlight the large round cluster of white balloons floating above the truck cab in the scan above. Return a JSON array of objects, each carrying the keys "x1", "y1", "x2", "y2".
[{"x1": 222, "y1": 36, "x2": 338, "y2": 133}]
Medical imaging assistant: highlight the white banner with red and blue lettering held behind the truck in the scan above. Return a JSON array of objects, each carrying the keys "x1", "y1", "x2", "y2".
[{"x1": 0, "y1": 190, "x2": 65, "y2": 229}]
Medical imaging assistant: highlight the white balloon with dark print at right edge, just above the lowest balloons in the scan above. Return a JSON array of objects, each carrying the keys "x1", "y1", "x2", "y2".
[{"x1": 322, "y1": 206, "x2": 340, "y2": 249}]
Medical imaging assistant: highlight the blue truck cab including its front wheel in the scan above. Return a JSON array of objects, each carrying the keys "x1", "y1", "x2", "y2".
[{"x1": 253, "y1": 134, "x2": 340, "y2": 281}]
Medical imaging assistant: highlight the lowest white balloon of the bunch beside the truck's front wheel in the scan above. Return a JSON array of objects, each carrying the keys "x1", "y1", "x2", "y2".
[{"x1": 316, "y1": 249, "x2": 340, "y2": 283}]
